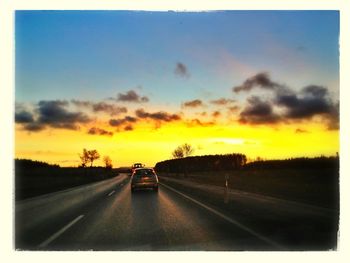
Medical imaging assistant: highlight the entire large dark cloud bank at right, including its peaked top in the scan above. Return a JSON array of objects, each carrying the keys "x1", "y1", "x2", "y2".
[{"x1": 234, "y1": 73, "x2": 339, "y2": 129}]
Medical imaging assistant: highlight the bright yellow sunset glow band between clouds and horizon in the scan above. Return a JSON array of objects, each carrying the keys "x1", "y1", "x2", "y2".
[{"x1": 15, "y1": 122, "x2": 339, "y2": 167}]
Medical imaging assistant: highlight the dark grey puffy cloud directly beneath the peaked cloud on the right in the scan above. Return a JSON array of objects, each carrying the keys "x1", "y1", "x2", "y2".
[{"x1": 239, "y1": 96, "x2": 280, "y2": 124}]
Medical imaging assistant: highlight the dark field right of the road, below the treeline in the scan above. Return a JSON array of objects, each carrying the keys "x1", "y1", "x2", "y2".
[{"x1": 160, "y1": 168, "x2": 339, "y2": 209}]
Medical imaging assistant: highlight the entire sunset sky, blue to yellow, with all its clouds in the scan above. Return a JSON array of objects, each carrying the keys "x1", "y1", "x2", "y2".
[{"x1": 15, "y1": 11, "x2": 339, "y2": 167}]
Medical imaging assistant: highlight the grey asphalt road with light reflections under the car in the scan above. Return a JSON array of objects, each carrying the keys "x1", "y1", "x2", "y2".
[{"x1": 15, "y1": 176, "x2": 338, "y2": 251}]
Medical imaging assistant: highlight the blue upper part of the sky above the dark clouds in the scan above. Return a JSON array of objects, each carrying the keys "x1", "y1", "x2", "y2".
[{"x1": 15, "y1": 11, "x2": 339, "y2": 106}]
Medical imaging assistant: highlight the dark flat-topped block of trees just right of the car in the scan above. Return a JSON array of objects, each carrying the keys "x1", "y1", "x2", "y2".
[{"x1": 155, "y1": 153, "x2": 247, "y2": 173}]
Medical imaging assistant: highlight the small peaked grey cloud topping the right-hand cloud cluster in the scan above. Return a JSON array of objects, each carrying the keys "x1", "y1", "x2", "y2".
[{"x1": 232, "y1": 72, "x2": 283, "y2": 93}]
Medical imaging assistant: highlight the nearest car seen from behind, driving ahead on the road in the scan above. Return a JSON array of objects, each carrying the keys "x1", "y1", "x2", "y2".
[{"x1": 131, "y1": 168, "x2": 159, "y2": 192}]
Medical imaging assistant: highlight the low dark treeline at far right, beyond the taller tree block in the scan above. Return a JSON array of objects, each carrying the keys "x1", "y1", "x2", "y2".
[{"x1": 244, "y1": 156, "x2": 339, "y2": 169}]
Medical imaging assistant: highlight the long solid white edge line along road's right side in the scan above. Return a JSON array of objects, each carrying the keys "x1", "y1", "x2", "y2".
[{"x1": 160, "y1": 183, "x2": 285, "y2": 250}]
